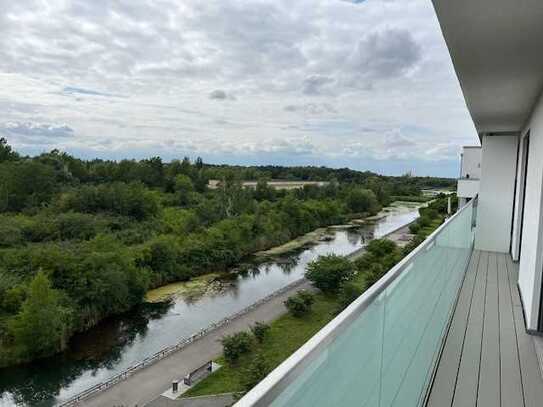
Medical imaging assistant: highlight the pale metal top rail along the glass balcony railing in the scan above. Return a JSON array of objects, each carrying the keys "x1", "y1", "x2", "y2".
[{"x1": 236, "y1": 197, "x2": 477, "y2": 407}]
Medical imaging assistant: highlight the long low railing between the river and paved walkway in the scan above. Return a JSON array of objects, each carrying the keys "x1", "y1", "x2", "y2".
[{"x1": 57, "y1": 278, "x2": 307, "y2": 407}]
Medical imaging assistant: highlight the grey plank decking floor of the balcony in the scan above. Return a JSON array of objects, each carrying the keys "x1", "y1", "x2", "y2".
[{"x1": 427, "y1": 251, "x2": 543, "y2": 407}]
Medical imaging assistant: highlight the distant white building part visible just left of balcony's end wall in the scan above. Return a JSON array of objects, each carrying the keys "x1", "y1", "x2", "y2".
[{"x1": 456, "y1": 146, "x2": 481, "y2": 208}]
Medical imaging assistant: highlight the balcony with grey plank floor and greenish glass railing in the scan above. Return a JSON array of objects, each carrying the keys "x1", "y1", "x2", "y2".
[{"x1": 237, "y1": 199, "x2": 543, "y2": 407}]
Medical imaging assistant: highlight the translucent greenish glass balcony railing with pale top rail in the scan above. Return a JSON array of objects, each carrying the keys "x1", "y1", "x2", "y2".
[{"x1": 236, "y1": 199, "x2": 477, "y2": 407}]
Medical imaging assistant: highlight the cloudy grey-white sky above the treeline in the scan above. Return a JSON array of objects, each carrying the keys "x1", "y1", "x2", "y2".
[{"x1": 0, "y1": 0, "x2": 478, "y2": 177}]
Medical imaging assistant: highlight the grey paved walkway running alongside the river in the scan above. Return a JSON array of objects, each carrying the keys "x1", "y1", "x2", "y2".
[{"x1": 79, "y1": 282, "x2": 311, "y2": 407}]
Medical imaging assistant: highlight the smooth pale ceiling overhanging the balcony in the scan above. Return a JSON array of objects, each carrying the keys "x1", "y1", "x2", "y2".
[{"x1": 432, "y1": 0, "x2": 543, "y2": 133}]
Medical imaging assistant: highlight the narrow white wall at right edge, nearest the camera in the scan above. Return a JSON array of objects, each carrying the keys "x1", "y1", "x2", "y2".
[{"x1": 515, "y1": 91, "x2": 543, "y2": 330}]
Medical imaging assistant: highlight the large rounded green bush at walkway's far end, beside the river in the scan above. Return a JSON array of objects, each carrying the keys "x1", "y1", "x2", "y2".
[{"x1": 305, "y1": 254, "x2": 354, "y2": 292}]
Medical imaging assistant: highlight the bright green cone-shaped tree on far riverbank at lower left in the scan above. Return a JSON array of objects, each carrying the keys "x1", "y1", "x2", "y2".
[{"x1": 9, "y1": 271, "x2": 68, "y2": 357}]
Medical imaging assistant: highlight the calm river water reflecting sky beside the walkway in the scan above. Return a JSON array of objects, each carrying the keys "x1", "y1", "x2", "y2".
[{"x1": 0, "y1": 207, "x2": 418, "y2": 407}]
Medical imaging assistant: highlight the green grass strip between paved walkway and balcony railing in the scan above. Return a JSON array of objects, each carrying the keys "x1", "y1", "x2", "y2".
[{"x1": 183, "y1": 293, "x2": 339, "y2": 397}]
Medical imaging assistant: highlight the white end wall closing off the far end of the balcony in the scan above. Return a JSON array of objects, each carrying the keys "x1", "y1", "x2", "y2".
[{"x1": 475, "y1": 135, "x2": 518, "y2": 253}]
